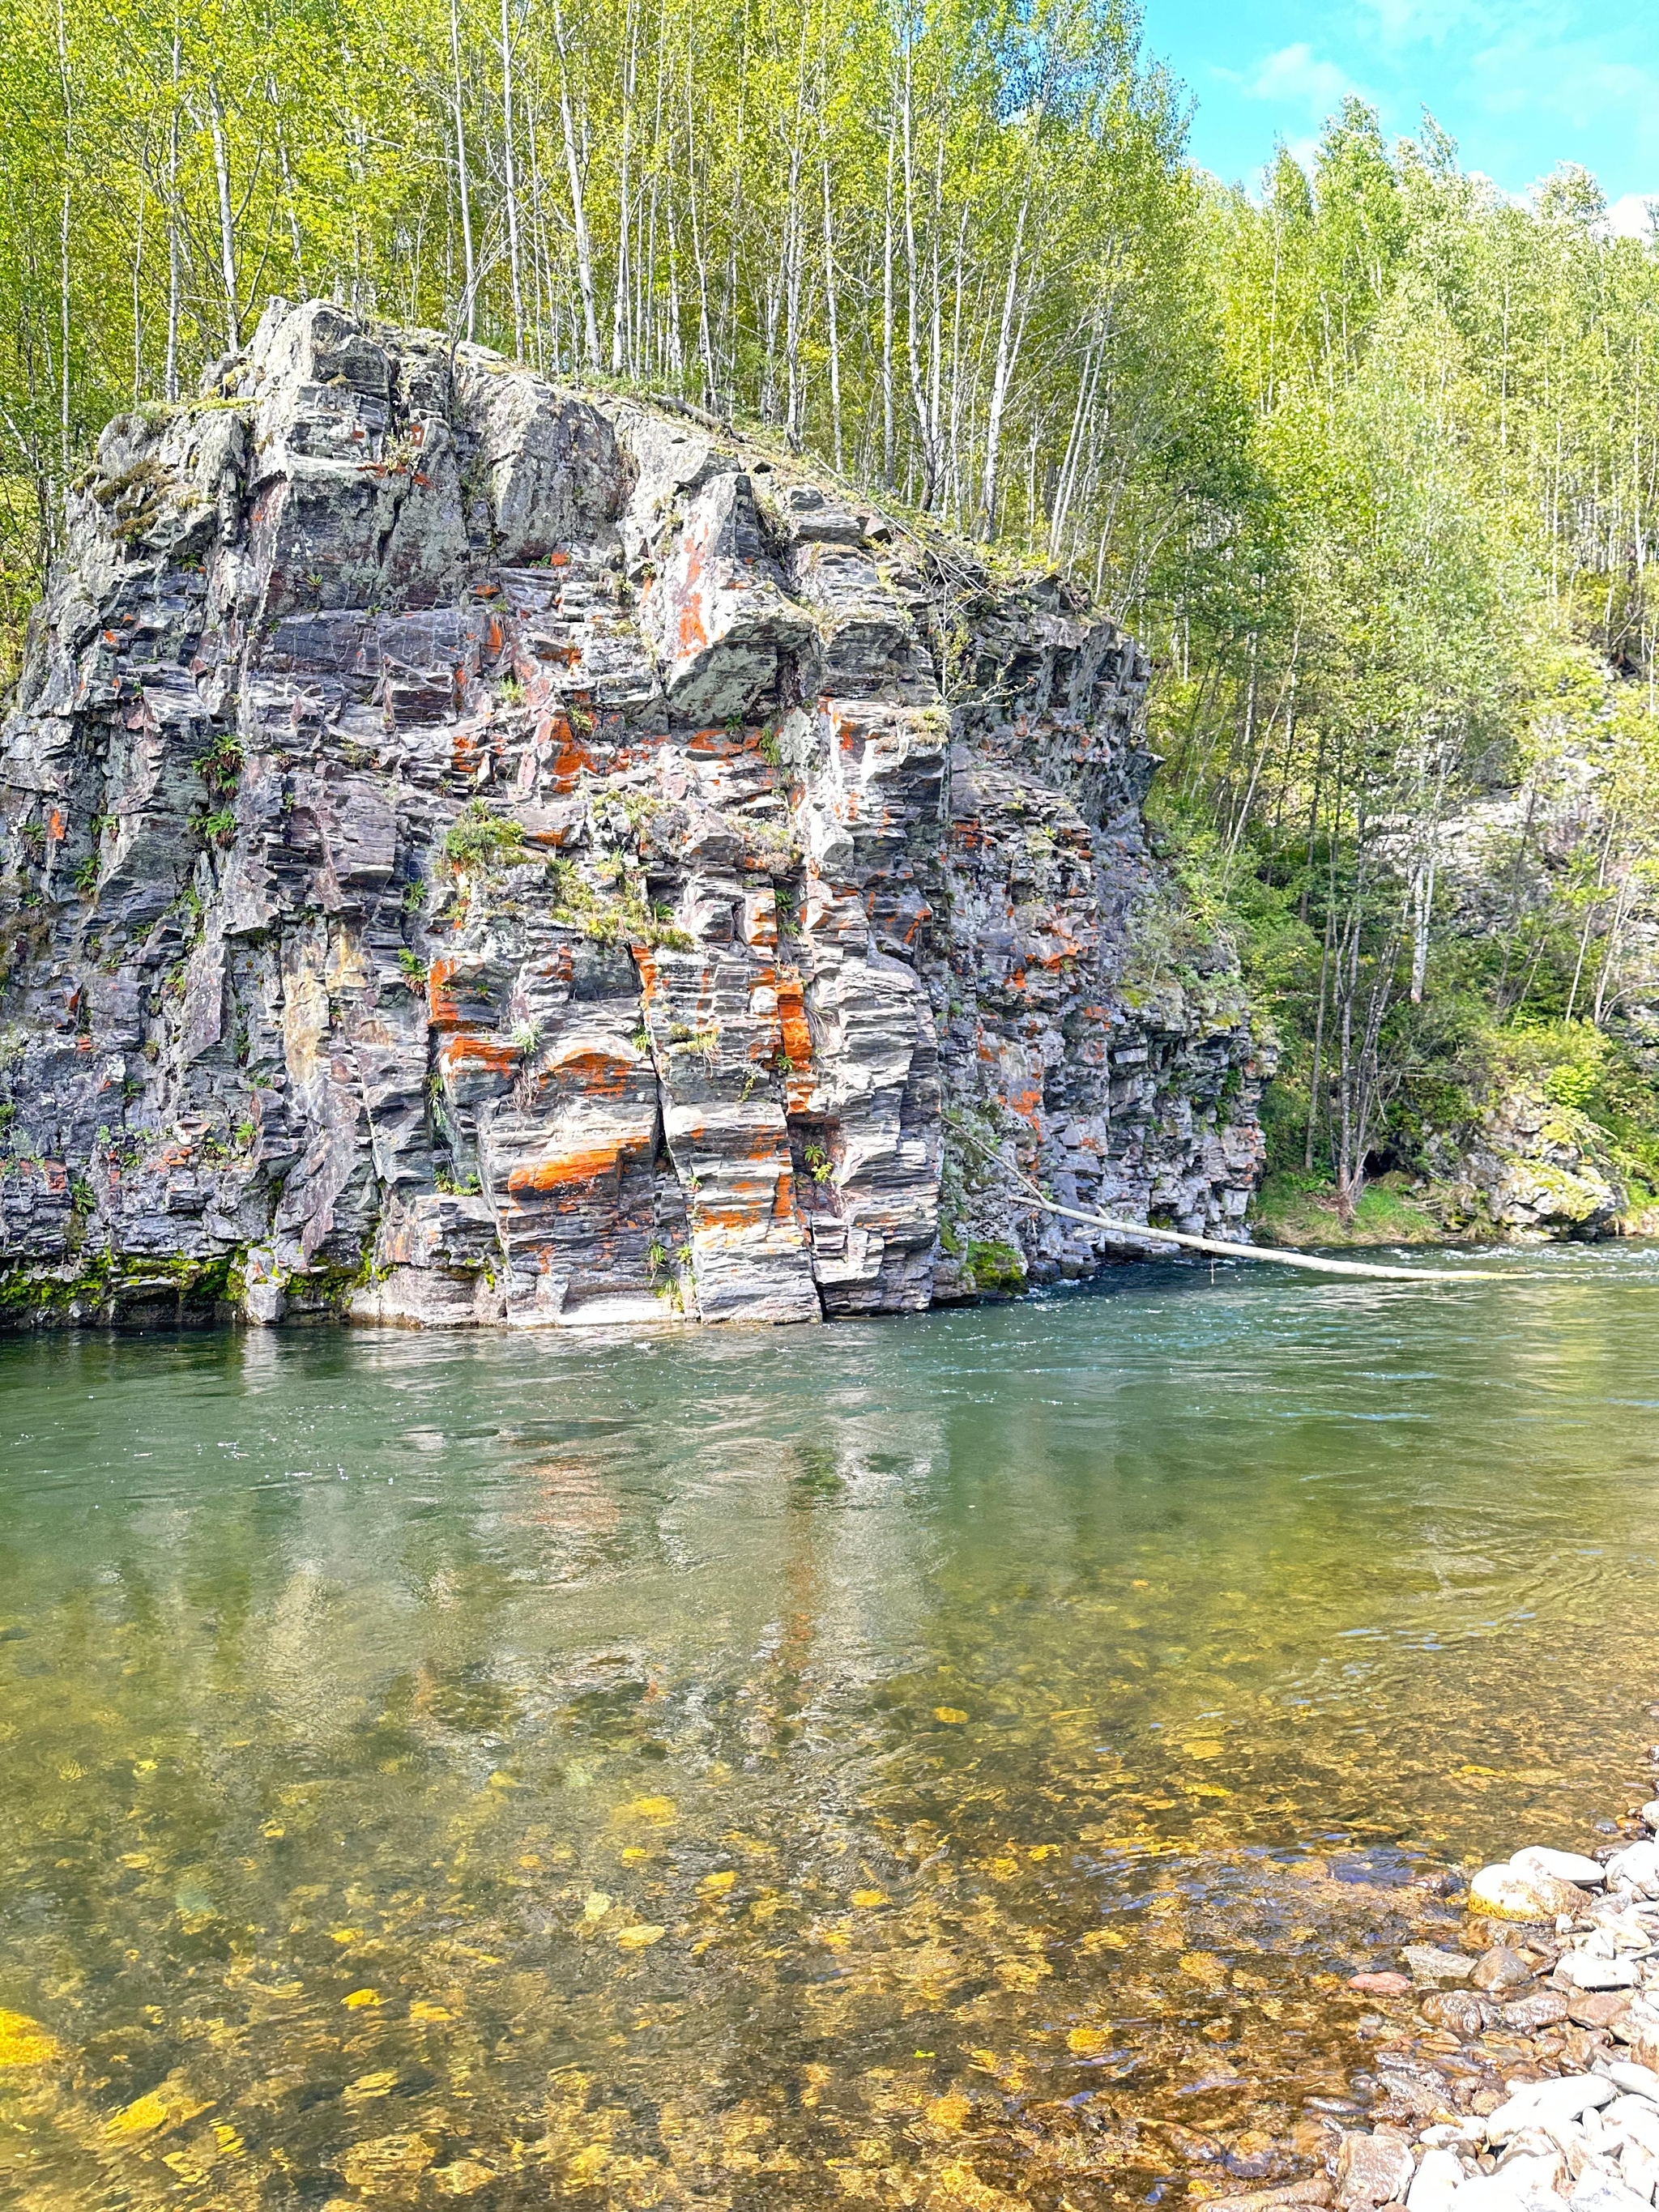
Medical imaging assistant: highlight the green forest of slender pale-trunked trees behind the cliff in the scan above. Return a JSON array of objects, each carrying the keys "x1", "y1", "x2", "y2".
[{"x1": 0, "y1": 0, "x2": 1659, "y2": 1237}]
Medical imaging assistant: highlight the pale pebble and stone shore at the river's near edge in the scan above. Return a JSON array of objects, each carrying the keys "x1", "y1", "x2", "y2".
[{"x1": 1223, "y1": 1745, "x2": 1659, "y2": 2212}]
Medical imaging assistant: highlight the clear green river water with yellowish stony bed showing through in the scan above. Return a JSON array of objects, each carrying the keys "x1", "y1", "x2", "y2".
[{"x1": 0, "y1": 1247, "x2": 1659, "y2": 2212}]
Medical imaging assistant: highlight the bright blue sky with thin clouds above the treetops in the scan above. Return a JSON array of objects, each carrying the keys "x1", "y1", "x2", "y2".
[{"x1": 1144, "y1": 0, "x2": 1659, "y2": 228}]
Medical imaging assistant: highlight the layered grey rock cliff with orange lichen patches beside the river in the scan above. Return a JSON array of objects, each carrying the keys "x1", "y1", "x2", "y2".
[{"x1": 0, "y1": 303, "x2": 1260, "y2": 1325}]
